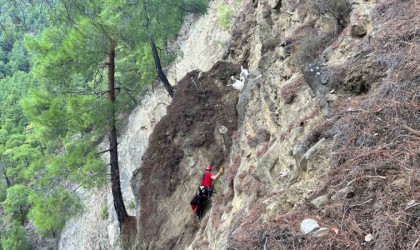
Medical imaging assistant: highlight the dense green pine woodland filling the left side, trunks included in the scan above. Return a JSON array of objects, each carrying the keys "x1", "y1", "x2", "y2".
[{"x1": 0, "y1": 0, "x2": 207, "y2": 249}]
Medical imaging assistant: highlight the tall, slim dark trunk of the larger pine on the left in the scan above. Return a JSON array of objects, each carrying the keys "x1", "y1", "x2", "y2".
[{"x1": 108, "y1": 39, "x2": 128, "y2": 228}]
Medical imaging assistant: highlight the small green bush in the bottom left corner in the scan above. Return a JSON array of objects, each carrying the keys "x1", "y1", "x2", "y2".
[{"x1": 1, "y1": 223, "x2": 32, "y2": 250}]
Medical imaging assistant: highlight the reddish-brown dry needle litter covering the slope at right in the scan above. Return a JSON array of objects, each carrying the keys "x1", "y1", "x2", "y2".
[{"x1": 225, "y1": 0, "x2": 420, "y2": 249}]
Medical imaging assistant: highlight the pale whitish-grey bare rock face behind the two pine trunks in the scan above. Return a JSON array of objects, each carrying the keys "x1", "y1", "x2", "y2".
[{"x1": 58, "y1": 1, "x2": 229, "y2": 249}]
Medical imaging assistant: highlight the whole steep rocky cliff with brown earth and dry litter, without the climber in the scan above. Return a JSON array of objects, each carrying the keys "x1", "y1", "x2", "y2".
[{"x1": 58, "y1": 0, "x2": 420, "y2": 249}]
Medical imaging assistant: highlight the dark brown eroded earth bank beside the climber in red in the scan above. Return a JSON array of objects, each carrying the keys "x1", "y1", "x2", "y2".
[{"x1": 132, "y1": 62, "x2": 240, "y2": 249}]
